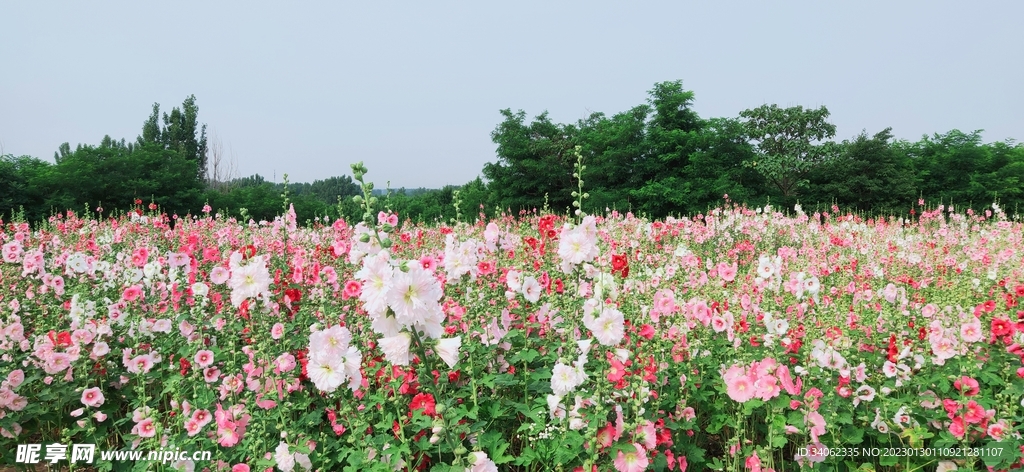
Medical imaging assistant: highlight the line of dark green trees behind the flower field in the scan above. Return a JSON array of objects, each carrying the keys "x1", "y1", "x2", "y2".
[{"x1": 0, "y1": 85, "x2": 1024, "y2": 227}]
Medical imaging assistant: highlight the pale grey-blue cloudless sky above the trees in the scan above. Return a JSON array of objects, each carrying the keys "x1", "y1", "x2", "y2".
[{"x1": 0, "y1": 0, "x2": 1024, "y2": 188}]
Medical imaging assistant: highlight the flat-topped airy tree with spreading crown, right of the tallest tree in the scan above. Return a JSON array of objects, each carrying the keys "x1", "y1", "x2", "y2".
[{"x1": 739, "y1": 104, "x2": 836, "y2": 200}]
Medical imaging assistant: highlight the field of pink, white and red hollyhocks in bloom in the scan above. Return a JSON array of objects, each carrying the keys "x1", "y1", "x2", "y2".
[{"x1": 0, "y1": 194, "x2": 1024, "y2": 466}]
